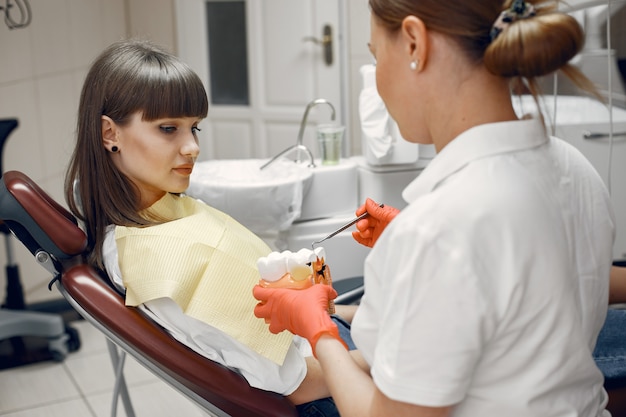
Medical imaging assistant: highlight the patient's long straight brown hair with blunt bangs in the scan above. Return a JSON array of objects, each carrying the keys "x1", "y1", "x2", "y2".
[{"x1": 65, "y1": 40, "x2": 208, "y2": 269}]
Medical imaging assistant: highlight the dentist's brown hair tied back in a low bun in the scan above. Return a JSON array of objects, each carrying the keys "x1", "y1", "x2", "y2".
[{"x1": 369, "y1": 0, "x2": 597, "y2": 96}]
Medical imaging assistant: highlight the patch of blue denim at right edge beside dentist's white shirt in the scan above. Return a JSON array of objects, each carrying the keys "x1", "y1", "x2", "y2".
[{"x1": 593, "y1": 308, "x2": 626, "y2": 388}]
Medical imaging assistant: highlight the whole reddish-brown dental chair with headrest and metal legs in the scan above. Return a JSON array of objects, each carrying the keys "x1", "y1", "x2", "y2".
[{"x1": 0, "y1": 171, "x2": 298, "y2": 417}]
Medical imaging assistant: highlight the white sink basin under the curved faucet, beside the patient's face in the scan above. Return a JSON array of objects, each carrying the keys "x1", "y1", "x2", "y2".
[{"x1": 186, "y1": 159, "x2": 313, "y2": 233}]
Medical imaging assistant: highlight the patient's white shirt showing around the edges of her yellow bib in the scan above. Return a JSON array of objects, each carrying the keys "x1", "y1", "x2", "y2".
[{"x1": 102, "y1": 226, "x2": 312, "y2": 395}]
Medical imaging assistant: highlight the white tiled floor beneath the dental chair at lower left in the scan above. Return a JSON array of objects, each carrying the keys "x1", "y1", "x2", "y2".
[{"x1": 0, "y1": 321, "x2": 210, "y2": 417}]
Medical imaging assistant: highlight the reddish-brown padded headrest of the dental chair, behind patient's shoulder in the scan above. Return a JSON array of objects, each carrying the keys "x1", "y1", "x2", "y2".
[{"x1": 0, "y1": 171, "x2": 87, "y2": 260}]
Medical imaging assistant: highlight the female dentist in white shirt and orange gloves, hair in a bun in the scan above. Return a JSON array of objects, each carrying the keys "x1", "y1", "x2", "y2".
[{"x1": 254, "y1": 0, "x2": 614, "y2": 417}]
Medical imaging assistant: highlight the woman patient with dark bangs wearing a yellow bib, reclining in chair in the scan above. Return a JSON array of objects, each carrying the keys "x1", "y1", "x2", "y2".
[{"x1": 65, "y1": 40, "x2": 344, "y2": 415}]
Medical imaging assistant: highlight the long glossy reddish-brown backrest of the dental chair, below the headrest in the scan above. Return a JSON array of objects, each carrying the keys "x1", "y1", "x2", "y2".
[{"x1": 60, "y1": 264, "x2": 297, "y2": 417}]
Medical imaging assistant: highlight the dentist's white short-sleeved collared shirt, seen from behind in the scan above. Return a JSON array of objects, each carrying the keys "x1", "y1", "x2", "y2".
[{"x1": 352, "y1": 120, "x2": 614, "y2": 417}]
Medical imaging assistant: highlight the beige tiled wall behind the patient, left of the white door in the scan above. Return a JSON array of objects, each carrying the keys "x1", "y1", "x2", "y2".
[{"x1": 0, "y1": 0, "x2": 176, "y2": 302}]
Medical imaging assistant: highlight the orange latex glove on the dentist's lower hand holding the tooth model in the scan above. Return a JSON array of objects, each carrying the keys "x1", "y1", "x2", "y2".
[{"x1": 252, "y1": 284, "x2": 348, "y2": 355}]
